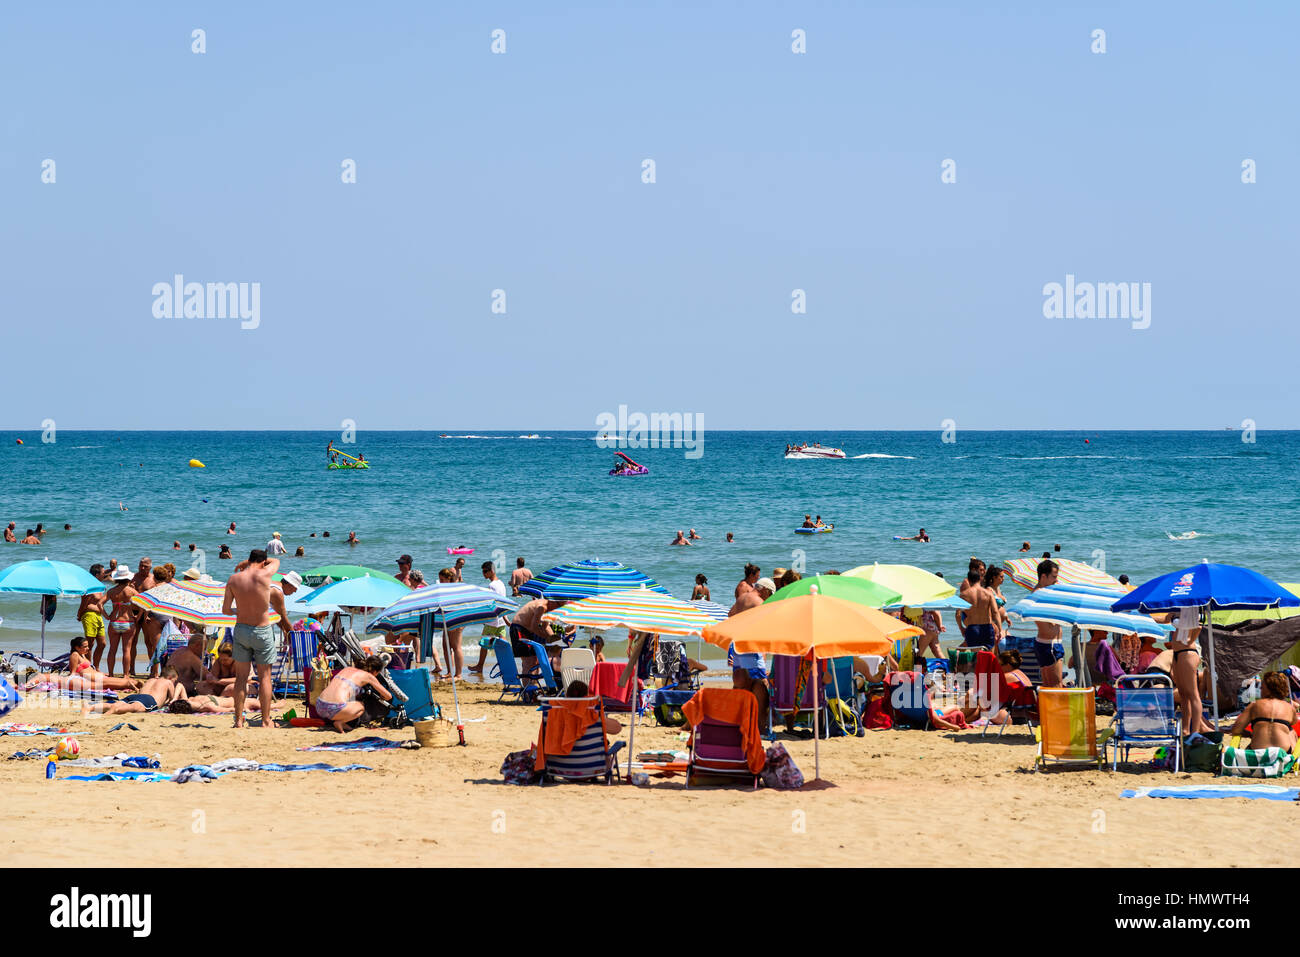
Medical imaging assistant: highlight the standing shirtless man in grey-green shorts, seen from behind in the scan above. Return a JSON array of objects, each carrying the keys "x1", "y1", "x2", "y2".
[{"x1": 221, "y1": 549, "x2": 290, "y2": 728}]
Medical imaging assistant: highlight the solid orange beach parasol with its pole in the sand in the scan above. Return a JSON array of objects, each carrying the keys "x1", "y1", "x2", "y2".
[{"x1": 703, "y1": 595, "x2": 922, "y2": 778}]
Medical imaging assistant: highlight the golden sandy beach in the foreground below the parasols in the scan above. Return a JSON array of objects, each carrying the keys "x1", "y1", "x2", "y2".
[{"x1": 0, "y1": 684, "x2": 1295, "y2": 867}]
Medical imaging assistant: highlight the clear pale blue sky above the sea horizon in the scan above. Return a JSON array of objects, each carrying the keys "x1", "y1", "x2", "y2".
[{"x1": 0, "y1": 1, "x2": 1300, "y2": 430}]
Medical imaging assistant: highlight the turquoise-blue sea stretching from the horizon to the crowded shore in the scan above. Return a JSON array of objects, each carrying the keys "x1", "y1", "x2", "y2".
[{"x1": 0, "y1": 425, "x2": 1300, "y2": 650}]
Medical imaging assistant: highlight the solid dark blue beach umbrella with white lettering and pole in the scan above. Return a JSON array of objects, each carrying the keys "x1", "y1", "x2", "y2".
[{"x1": 1110, "y1": 562, "x2": 1300, "y2": 722}]
